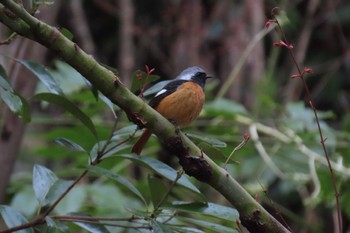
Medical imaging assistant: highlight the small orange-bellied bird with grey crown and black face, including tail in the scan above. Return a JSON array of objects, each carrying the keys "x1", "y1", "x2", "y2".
[{"x1": 131, "y1": 66, "x2": 211, "y2": 155}]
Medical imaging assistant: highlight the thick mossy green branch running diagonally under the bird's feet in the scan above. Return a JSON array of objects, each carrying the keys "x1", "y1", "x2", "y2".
[{"x1": 0, "y1": 0, "x2": 289, "y2": 232}]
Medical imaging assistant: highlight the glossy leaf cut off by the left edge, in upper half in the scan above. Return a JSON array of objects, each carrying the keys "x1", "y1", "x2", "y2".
[{"x1": 0, "y1": 65, "x2": 30, "y2": 122}]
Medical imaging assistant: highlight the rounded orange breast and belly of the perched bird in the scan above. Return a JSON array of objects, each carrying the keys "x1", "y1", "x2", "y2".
[{"x1": 155, "y1": 82, "x2": 205, "y2": 126}]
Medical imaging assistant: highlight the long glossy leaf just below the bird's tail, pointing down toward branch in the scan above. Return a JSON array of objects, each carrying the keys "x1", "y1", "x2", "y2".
[{"x1": 117, "y1": 154, "x2": 204, "y2": 198}]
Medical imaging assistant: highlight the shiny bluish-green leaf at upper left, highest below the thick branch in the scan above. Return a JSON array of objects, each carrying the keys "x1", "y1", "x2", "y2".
[{"x1": 17, "y1": 60, "x2": 63, "y2": 95}]
